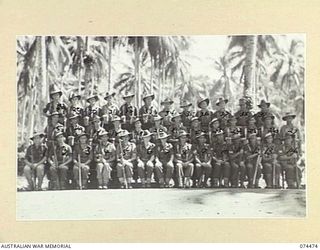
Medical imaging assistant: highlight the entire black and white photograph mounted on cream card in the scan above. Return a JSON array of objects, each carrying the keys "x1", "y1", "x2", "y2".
[{"x1": 13, "y1": 34, "x2": 307, "y2": 221}]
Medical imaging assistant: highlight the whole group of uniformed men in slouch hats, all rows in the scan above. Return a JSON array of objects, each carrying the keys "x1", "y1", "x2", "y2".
[{"x1": 24, "y1": 85, "x2": 301, "y2": 190}]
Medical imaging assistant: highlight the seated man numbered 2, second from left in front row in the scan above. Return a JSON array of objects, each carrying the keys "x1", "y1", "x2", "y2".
[{"x1": 48, "y1": 132, "x2": 72, "y2": 190}]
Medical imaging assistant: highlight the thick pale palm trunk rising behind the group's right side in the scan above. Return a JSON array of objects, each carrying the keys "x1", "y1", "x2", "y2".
[{"x1": 243, "y1": 36, "x2": 257, "y2": 102}]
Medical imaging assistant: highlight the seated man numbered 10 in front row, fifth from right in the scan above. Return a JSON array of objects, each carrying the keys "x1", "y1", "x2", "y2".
[{"x1": 212, "y1": 130, "x2": 230, "y2": 187}]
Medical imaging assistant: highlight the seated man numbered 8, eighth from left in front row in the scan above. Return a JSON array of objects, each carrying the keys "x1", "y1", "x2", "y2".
[{"x1": 175, "y1": 130, "x2": 194, "y2": 188}]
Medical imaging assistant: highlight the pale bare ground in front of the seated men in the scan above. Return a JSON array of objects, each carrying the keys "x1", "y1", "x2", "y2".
[{"x1": 17, "y1": 188, "x2": 306, "y2": 220}]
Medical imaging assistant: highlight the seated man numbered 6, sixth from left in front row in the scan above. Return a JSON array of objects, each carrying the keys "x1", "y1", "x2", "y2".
[{"x1": 137, "y1": 130, "x2": 156, "y2": 188}]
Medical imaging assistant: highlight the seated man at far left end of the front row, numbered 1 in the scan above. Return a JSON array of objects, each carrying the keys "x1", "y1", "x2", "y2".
[{"x1": 23, "y1": 132, "x2": 47, "y2": 191}]
